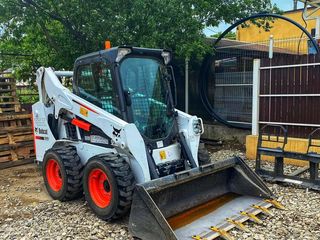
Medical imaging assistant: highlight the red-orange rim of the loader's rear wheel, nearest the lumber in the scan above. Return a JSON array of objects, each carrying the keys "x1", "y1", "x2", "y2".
[{"x1": 46, "y1": 159, "x2": 63, "y2": 192}]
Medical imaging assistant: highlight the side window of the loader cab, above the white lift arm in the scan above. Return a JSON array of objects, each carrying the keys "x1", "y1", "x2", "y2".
[{"x1": 77, "y1": 62, "x2": 121, "y2": 118}]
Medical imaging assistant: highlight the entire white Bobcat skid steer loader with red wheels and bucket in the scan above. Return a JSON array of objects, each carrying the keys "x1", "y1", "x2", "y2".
[{"x1": 32, "y1": 46, "x2": 281, "y2": 240}]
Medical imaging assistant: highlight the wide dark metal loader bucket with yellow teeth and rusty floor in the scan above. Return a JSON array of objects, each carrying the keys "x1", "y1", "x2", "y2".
[{"x1": 129, "y1": 157, "x2": 280, "y2": 240}]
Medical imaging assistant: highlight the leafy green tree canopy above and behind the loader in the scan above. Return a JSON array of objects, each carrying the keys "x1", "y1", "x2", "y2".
[{"x1": 0, "y1": 0, "x2": 274, "y2": 77}]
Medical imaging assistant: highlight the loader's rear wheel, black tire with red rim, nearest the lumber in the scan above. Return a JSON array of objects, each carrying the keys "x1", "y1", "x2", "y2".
[{"x1": 42, "y1": 145, "x2": 83, "y2": 201}]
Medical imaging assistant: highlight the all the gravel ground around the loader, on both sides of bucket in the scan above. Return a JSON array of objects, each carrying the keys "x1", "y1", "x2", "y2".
[{"x1": 0, "y1": 149, "x2": 320, "y2": 240}]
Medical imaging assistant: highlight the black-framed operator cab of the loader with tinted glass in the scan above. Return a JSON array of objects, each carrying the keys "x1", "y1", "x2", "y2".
[{"x1": 73, "y1": 47, "x2": 178, "y2": 149}]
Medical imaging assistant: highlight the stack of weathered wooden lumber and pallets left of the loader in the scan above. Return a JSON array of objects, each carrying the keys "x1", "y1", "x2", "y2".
[{"x1": 0, "y1": 77, "x2": 34, "y2": 169}]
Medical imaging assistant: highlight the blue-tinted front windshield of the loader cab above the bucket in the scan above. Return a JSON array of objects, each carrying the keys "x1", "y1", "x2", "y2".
[{"x1": 120, "y1": 57, "x2": 173, "y2": 139}]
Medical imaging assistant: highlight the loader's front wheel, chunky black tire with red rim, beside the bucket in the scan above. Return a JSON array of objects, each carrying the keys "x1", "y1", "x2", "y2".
[{"x1": 83, "y1": 153, "x2": 135, "y2": 220}]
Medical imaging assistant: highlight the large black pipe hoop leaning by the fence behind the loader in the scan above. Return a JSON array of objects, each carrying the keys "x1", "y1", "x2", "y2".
[{"x1": 199, "y1": 13, "x2": 319, "y2": 130}]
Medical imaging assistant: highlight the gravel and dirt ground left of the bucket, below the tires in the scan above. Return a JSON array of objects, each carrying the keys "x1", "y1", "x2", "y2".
[{"x1": 0, "y1": 164, "x2": 132, "y2": 240}]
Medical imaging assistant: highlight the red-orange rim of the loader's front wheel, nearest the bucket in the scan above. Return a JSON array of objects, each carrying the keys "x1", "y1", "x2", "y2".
[{"x1": 88, "y1": 168, "x2": 112, "y2": 208}]
